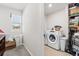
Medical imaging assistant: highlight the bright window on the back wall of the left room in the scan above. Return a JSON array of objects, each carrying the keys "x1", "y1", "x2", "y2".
[{"x1": 11, "y1": 14, "x2": 22, "y2": 34}]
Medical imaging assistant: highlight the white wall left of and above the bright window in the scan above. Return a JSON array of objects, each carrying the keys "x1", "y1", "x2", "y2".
[{"x1": 0, "y1": 6, "x2": 21, "y2": 34}]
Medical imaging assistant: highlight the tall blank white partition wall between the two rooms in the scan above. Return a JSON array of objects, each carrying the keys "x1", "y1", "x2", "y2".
[{"x1": 23, "y1": 3, "x2": 44, "y2": 56}]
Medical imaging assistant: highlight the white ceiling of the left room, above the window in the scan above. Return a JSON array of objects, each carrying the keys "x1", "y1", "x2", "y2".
[{"x1": 0, "y1": 3, "x2": 27, "y2": 11}]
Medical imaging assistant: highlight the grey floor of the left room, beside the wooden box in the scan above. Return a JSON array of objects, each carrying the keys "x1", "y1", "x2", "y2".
[{"x1": 4, "y1": 45, "x2": 30, "y2": 56}]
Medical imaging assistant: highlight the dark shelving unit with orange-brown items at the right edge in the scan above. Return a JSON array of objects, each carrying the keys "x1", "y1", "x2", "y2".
[{"x1": 69, "y1": 3, "x2": 79, "y2": 55}]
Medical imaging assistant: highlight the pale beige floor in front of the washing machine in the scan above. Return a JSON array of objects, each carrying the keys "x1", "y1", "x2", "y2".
[{"x1": 44, "y1": 46, "x2": 72, "y2": 56}]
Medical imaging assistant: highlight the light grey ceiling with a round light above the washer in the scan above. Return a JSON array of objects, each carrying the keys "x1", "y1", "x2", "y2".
[{"x1": 44, "y1": 3, "x2": 67, "y2": 15}]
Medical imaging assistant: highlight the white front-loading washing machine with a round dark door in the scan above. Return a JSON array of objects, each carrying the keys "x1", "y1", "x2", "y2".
[{"x1": 47, "y1": 32, "x2": 60, "y2": 50}]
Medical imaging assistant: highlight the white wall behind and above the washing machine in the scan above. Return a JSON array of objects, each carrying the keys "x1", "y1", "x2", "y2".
[{"x1": 47, "y1": 5, "x2": 68, "y2": 37}]
